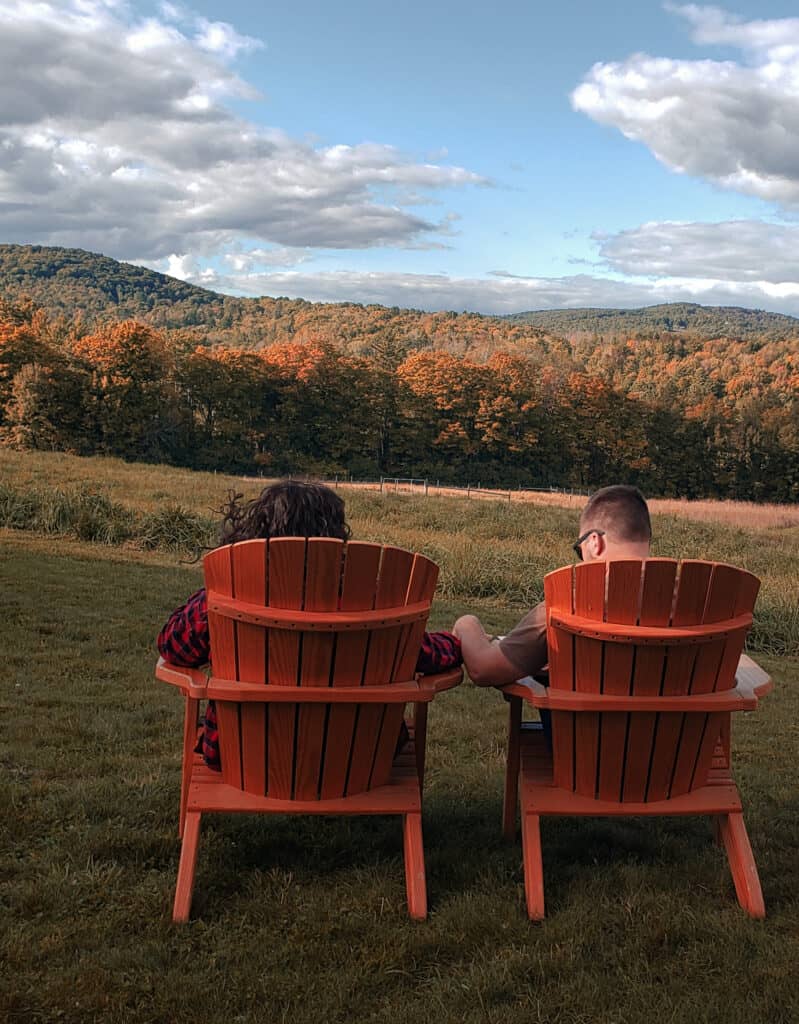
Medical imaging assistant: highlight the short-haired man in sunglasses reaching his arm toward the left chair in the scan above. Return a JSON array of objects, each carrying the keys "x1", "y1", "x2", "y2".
[{"x1": 453, "y1": 483, "x2": 651, "y2": 686}]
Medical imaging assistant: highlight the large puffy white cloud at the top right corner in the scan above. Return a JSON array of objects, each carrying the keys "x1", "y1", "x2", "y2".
[{"x1": 572, "y1": 4, "x2": 799, "y2": 207}]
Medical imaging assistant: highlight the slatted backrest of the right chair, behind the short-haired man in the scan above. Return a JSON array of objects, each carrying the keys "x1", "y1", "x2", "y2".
[{"x1": 544, "y1": 558, "x2": 760, "y2": 803}]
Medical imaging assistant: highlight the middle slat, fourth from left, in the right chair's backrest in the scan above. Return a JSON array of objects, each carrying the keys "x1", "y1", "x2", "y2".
[{"x1": 622, "y1": 558, "x2": 677, "y2": 803}]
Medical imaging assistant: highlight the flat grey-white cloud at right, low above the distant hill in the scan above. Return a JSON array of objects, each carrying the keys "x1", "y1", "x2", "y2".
[{"x1": 596, "y1": 220, "x2": 799, "y2": 287}]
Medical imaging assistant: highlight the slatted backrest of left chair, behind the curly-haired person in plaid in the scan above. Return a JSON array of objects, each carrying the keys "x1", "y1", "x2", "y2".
[{"x1": 199, "y1": 538, "x2": 438, "y2": 801}]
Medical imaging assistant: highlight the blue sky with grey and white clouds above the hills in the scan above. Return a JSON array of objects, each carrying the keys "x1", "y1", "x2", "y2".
[{"x1": 0, "y1": 0, "x2": 799, "y2": 314}]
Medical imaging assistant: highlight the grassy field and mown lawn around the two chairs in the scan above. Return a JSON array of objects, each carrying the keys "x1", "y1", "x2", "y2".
[{"x1": 0, "y1": 453, "x2": 799, "y2": 1024}]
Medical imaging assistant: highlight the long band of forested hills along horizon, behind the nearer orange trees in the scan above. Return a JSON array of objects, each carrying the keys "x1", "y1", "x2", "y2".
[{"x1": 0, "y1": 245, "x2": 799, "y2": 359}]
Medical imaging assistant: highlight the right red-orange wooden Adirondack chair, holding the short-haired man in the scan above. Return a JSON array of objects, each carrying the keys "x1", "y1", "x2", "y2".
[{"x1": 503, "y1": 558, "x2": 771, "y2": 920}]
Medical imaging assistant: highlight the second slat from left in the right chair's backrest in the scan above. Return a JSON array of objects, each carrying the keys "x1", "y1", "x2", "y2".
[{"x1": 575, "y1": 562, "x2": 606, "y2": 797}]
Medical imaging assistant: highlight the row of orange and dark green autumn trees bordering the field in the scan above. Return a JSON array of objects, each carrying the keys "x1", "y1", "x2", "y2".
[{"x1": 0, "y1": 300, "x2": 799, "y2": 501}]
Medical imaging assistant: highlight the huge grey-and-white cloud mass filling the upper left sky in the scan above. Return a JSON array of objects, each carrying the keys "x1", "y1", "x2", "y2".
[{"x1": 0, "y1": 0, "x2": 486, "y2": 261}]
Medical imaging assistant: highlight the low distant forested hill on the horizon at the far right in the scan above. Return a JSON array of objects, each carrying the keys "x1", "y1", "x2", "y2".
[{"x1": 505, "y1": 302, "x2": 799, "y2": 340}]
